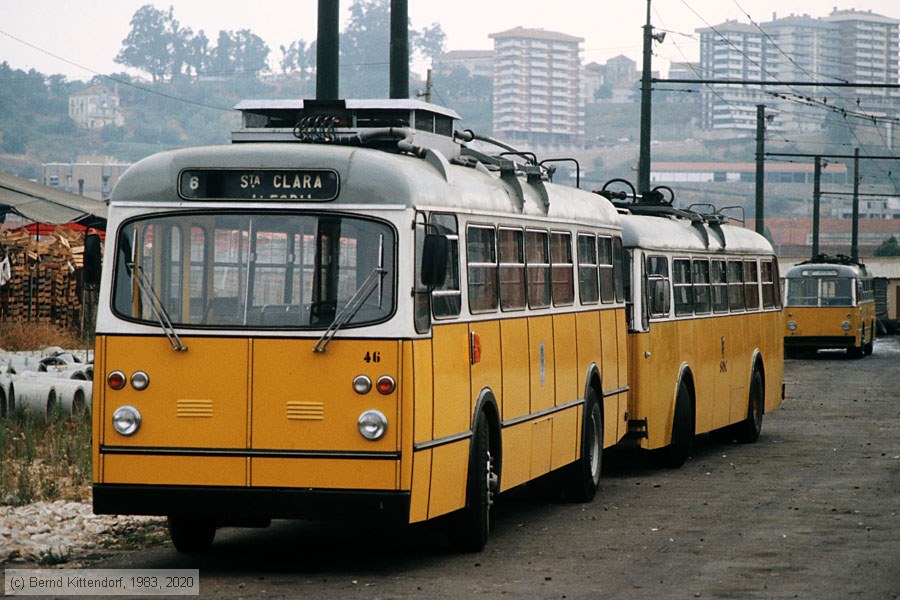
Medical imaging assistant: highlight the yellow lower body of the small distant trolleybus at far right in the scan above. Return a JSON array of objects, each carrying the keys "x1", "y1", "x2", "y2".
[{"x1": 784, "y1": 300, "x2": 875, "y2": 350}]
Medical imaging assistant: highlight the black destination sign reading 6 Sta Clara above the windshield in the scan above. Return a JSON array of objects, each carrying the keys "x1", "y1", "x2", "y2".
[{"x1": 178, "y1": 169, "x2": 340, "y2": 202}]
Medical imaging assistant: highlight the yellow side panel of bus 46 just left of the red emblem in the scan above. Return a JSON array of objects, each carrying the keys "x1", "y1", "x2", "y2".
[{"x1": 432, "y1": 323, "x2": 472, "y2": 438}]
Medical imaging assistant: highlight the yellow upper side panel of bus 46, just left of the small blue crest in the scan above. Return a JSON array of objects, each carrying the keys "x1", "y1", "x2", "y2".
[{"x1": 497, "y1": 319, "x2": 531, "y2": 422}]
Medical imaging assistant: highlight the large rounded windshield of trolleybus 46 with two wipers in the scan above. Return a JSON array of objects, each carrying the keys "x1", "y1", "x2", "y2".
[{"x1": 113, "y1": 212, "x2": 395, "y2": 329}]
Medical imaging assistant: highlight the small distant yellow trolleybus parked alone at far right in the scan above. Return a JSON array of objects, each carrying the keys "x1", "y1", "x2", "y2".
[{"x1": 784, "y1": 254, "x2": 876, "y2": 357}]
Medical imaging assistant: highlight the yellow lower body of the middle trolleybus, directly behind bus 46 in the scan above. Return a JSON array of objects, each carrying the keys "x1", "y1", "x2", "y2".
[{"x1": 628, "y1": 311, "x2": 784, "y2": 449}]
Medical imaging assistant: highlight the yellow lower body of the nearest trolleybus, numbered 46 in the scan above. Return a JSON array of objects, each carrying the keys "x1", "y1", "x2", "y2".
[{"x1": 94, "y1": 309, "x2": 628, "y2": 522}]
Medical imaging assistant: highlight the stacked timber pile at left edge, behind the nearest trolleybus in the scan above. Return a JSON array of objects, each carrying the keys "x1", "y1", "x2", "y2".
[{"x1": 0, "y1": 226, "x2": 84, "y2": 329}]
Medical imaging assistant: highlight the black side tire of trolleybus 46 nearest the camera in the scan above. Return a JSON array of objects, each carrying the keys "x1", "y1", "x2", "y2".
[{"x1": 450, "y1": 416, "x2": 499, "y2": 552}]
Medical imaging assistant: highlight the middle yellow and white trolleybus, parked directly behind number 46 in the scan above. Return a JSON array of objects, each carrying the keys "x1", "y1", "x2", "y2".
[{"x1": 601, "y1": 180, "x2": 784, "y2": 467}]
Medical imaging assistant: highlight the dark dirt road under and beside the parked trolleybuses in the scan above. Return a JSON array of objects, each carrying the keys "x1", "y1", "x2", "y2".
[{"x1": 21, "y1": 338, "x2": 900, "y2": 600}]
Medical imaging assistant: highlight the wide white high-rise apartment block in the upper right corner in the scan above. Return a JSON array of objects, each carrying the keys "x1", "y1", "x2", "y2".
[{"x1": 697, "y1": 10, "x2": 900, "y2": 131}]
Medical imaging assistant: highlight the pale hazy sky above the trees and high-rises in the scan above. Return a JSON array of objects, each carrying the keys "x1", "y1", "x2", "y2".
[{"x1": 0, "y1": 0, "x2": 900, "y2": 79}]
